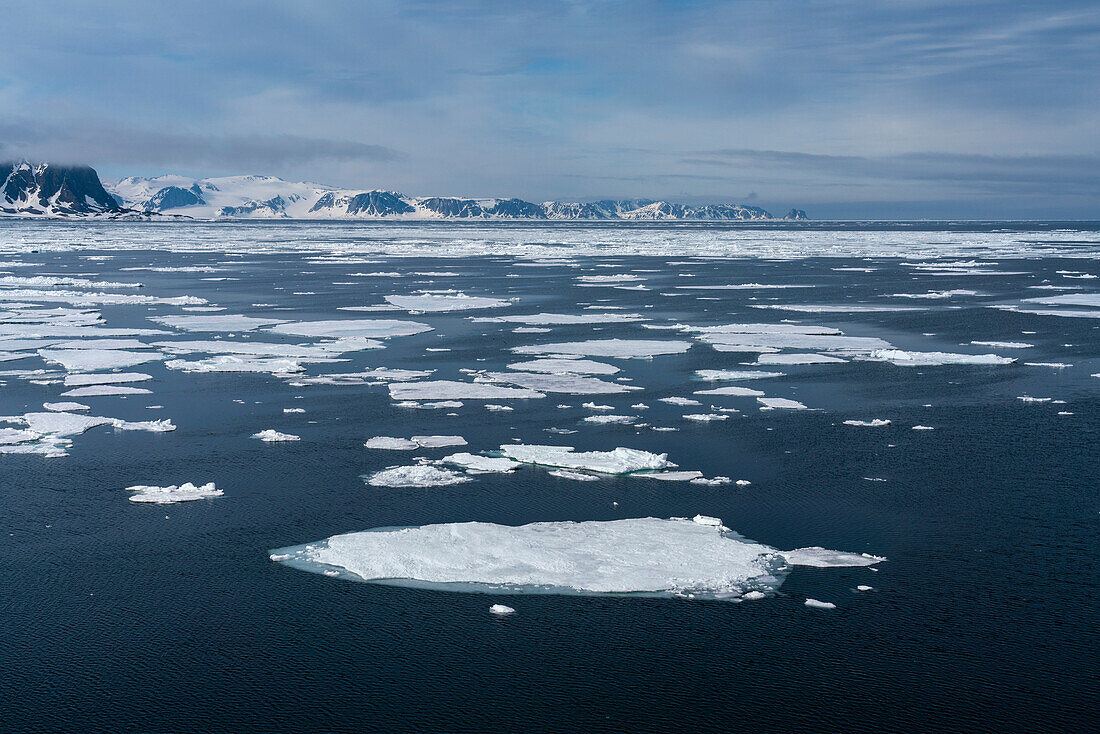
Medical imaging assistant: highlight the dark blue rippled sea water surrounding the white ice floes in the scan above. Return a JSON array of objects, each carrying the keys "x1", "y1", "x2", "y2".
[{"x1": 0, "y1": 222, "x2": 1100, "y2": 733}]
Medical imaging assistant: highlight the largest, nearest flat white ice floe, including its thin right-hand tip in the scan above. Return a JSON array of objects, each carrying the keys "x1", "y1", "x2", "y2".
[{"x1": 271, "y1": 515, "x2": 884, "y2": 600}]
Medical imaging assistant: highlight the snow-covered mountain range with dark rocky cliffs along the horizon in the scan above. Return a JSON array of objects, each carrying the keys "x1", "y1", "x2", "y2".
[{"x1": 0, "y1": 162, "x2": 806, "y2": 221}]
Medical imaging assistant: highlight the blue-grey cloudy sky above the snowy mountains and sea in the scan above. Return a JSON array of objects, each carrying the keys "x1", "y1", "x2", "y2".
[{"x1": 0, "y1": 0, "x2": 1100, "y2": 219}]
